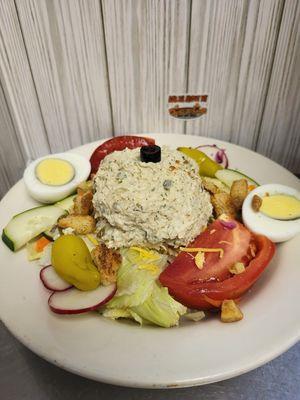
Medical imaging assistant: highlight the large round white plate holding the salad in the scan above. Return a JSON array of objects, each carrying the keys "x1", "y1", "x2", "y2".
[{"x1": 0, "y1": 134, "x2": 300, "y2": 388}]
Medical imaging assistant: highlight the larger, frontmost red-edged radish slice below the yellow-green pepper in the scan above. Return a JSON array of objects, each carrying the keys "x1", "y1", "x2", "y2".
[{"x1": 48, "y1": 283, "x2": 117, "y2": 314}]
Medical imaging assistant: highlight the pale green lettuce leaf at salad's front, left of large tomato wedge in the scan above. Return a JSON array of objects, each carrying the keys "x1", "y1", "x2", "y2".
[{"x1": 103, "y1": 247, "x2": 186, "y2": 327}]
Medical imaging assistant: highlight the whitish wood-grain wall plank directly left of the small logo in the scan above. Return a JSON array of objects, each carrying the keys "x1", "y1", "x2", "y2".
[{"x1": 102, "y1": 0, "x2": 191, "y2": 134}]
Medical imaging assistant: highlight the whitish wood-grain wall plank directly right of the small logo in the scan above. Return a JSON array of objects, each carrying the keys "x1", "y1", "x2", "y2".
[{"x1": 187, "y1": 0, "x2": 283, "y2": 149}]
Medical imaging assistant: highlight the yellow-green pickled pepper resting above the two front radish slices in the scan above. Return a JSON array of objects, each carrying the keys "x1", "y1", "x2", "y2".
[{"x1": 51, "y1": 235, "x2": 100, "y2": 290}]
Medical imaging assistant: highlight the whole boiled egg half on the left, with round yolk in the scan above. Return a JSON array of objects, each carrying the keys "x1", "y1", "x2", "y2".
[{"x1": 23, "y1": 153, "x2": 91, "y2": 203}]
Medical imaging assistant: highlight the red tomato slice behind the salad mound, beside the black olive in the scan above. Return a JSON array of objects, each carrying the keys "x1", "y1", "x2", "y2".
[{"x1": 90, "y1": 136, "x2": 155, "y2": 174}]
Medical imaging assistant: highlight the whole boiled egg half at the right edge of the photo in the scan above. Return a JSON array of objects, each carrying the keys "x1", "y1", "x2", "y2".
[{"x1": 242, "y1": 183, "x2": 300, "y2": 243}]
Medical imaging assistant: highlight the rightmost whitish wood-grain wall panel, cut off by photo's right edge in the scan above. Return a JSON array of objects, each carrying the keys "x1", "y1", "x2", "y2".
[{"x1": 257, "y1": 0, "x2": 300, "y2": 174}]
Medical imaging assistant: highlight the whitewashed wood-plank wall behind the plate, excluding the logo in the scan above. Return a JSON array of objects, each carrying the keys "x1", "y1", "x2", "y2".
[{"x1": 0, "y1": 0, "x2": 300, "y2": 197}]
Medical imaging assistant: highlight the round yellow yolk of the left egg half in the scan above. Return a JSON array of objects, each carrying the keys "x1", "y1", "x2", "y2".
[{"x1": 35, "y1": 158, "x2": 75, "y2": 186}]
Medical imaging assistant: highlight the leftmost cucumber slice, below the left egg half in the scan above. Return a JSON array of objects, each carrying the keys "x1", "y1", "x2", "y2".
[{"x1": 2, "y1": 205, "x2": 66, "y2": 251}]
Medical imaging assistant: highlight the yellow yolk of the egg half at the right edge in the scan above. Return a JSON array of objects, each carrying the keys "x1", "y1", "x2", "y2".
[{"x1": 259, "y1": 194, "x2": 300, "y2": 220}]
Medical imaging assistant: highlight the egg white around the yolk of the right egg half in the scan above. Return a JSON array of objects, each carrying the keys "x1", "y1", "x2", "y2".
[{"x1": 242, "y1": 183, "x2": 300, "y2": 243}]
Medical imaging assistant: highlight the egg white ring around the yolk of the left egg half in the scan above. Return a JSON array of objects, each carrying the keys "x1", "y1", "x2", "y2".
[{"x1": 23, "y1": 153, "x2": 91, "y2": 204}]
